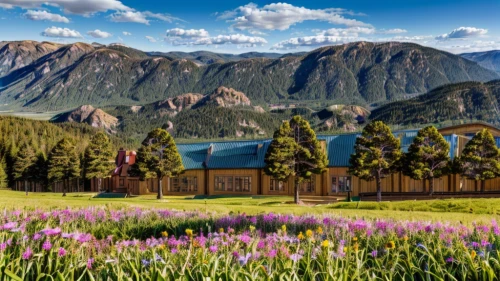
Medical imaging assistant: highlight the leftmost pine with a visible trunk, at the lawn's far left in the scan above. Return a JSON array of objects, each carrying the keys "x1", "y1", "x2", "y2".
[{"x1": 12, "y1": 144, "x2": 36, "y2": 195}]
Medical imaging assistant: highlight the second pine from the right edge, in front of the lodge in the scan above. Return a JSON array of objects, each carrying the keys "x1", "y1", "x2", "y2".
[{"x1": 402, "y1": 126, "x2": 450, "y2": 195}]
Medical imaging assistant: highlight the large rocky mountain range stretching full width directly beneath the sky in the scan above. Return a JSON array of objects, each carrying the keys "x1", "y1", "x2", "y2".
[{"x1": 0, "y1": 41, "x2": 499, "y2": 111}]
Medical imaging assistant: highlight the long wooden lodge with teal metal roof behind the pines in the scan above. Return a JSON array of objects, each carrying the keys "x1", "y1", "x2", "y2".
[{"x1": 92, "y1": 123, "x2": 500, "y2": 200}]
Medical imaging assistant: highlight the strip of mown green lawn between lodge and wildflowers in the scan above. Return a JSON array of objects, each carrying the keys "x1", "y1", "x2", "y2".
[{"x1": 0, "y1": 190, "x2": 500, "y2": 224}]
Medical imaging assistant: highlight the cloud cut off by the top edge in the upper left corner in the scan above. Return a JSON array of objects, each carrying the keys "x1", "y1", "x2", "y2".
[{"x1": 0, "y1": 0, "x2": 132, "y2": 16}]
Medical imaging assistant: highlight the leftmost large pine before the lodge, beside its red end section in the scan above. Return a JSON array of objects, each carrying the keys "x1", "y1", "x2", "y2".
[{"x1": 134, "y1": 128, "x2": 184, "y2": 199}]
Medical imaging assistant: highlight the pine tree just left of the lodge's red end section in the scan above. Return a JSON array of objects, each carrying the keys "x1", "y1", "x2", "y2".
[{"x1": 84, "y1": 132, "x2": 114, "y2": 190}]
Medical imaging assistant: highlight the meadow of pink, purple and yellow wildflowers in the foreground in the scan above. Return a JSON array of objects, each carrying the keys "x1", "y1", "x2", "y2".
[{"x1": 0, "y1": 207, "x2": 500, "y2": 281}]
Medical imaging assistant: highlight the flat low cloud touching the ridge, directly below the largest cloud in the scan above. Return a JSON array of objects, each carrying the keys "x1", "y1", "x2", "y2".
[{"x1": 271, "y1": 35, "x2": 360, "y2": 50}]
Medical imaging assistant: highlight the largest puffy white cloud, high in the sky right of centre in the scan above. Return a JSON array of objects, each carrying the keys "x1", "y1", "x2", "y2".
[{"x1": 218, "y1": 3, "x2": 370, "y2": 30}]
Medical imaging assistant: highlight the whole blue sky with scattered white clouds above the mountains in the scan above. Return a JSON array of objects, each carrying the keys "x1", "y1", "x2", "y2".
[{"x1": 0, "y1": 0, "x2": 500, "y2": 53}]
